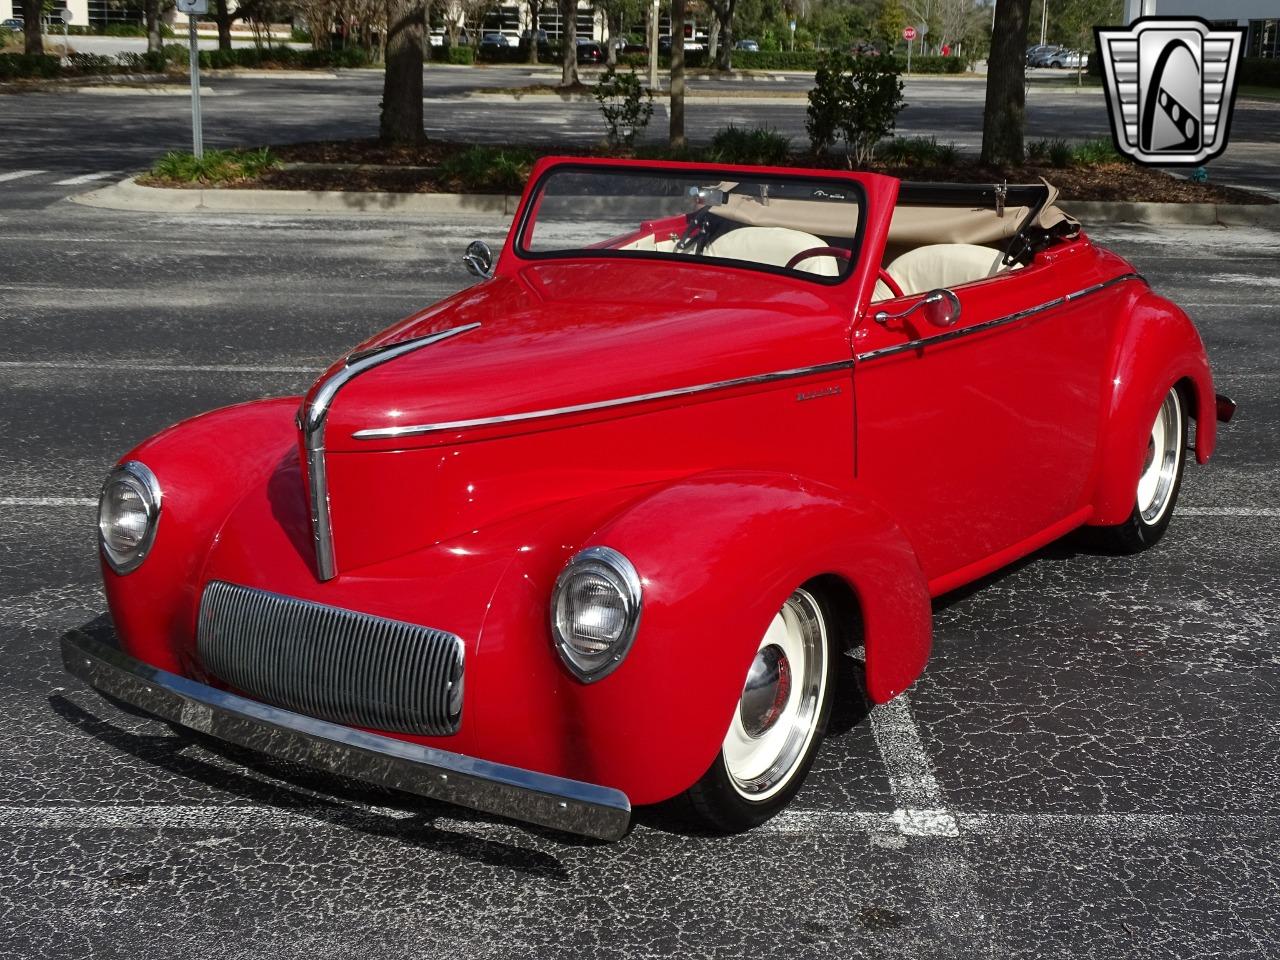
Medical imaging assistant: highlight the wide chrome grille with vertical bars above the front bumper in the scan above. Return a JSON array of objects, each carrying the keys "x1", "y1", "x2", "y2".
[{"x1": 196, "y1": 580, "x2": 463, "y2": 736}]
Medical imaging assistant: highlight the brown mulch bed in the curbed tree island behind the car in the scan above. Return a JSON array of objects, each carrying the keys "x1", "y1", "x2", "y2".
[{"x1": 160, "y1": 140, "x2": 1276, "y2": 204}]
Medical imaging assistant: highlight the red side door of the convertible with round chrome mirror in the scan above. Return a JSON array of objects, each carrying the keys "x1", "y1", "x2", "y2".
[{"x1": 854, "y1": 257, "x2": 1110, "y2": 594}]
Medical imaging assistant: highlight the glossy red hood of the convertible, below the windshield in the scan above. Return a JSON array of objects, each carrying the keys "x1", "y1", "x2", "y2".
[{"x1": 308, "y1": 260, "x2": 852, "y2": 452}]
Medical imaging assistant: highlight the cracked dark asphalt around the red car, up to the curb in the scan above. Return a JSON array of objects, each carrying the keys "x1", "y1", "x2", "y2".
[{"x1": 0, "y1": 182, "x2": 1280, "y2": 960}]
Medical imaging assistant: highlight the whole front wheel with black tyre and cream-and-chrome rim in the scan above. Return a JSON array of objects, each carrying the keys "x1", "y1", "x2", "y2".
[{"x1": 689, "y1": 589, "x2": 835, "y2": 833}]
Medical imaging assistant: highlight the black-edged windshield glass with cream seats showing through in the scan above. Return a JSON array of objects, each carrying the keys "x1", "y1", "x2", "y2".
[{"x1": 516, "y1": 165, "x2": 864, "y2": 283}]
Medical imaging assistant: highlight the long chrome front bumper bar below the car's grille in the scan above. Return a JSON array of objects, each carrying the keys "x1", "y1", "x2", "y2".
[{"x1": 61, "y1": 630, "x2": 631, "y2": 840}]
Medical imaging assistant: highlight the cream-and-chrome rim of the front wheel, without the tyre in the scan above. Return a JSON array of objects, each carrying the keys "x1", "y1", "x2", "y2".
[{"x1": 722, "y1": 590, "x2": 828, "y2": 801}]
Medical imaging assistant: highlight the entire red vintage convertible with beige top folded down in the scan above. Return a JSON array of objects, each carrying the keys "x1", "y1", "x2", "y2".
[{"x1": 63, "y1": 159, "x2": 1234, "y2": 838}]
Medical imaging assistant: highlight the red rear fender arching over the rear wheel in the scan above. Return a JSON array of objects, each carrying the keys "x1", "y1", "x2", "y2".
[{"x1": 1089, "y1": 288, "x2": 1217, "y2": 526}]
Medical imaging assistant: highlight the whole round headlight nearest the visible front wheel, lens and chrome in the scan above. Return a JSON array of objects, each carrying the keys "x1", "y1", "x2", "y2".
[{"x1": 552, "y1": 547, "x2": 640, "y2": 684}]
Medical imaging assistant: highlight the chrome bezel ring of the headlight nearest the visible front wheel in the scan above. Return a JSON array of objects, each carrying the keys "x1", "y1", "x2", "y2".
[{"x1": 550, "y1": 547, "x2": 644, "y2": 684}]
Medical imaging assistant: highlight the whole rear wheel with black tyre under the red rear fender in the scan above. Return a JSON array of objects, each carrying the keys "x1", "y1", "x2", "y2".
[{"x1": 1094, "y1": 387, "x2": 1187, "y2": 553}]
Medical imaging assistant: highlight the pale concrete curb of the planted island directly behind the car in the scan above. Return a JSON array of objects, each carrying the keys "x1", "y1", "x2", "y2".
[{"x1": 70, "y1": 178, "x2": 1280, "y2": 229}]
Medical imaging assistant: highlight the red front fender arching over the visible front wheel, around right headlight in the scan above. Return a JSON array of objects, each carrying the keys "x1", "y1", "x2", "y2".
[{"x1": 480, "y1": 472, "x2": 931, "y2": 804}]
